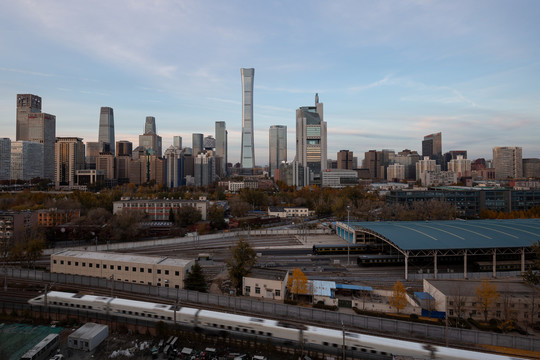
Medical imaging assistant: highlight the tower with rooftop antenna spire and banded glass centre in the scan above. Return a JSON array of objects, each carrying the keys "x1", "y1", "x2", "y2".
[{"x1": 296, "y1": 94, "x2": 327, "y2": 186}]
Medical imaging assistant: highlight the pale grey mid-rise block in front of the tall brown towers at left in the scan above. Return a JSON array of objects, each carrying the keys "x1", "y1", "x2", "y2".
[{"x1": 10, "y1": 141, "x2": 43, "y2": 181}]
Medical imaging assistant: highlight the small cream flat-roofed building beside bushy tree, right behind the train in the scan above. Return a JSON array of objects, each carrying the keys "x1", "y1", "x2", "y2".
[{"x1": 242, "y1": 268, "x2": 289, "y2": 300}]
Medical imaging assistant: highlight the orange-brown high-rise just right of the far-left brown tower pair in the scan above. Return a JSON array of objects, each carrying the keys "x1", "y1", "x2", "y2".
[{"x1": 54, "y1": 137, "x2": 85, "y2": 189}]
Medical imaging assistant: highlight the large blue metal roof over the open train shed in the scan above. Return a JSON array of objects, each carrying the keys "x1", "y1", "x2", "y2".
[{"x1": 350, "y1": 219, "x2": 540, "y2": 250}]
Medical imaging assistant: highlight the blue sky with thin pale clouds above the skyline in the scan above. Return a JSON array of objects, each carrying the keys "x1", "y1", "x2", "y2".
[{"x1": 0, "y1": 0, "x2": 540, "y2": 165}]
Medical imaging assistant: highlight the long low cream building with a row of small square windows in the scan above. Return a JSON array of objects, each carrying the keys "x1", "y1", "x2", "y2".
[{"x1": 51, "y1": 250, "x2": 195, "y2": 289}]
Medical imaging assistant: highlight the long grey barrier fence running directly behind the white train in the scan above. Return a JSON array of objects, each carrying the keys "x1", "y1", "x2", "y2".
[{"x1": 6, "y1": 268, "x2": 540, "y2": 351}]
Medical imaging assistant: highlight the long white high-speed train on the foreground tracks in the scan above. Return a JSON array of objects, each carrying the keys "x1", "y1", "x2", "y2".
[{"x1": 28, "y1": 291, "x2": 522, "y2": 360}]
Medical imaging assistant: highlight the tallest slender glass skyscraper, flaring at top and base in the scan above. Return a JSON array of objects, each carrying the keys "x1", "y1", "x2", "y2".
[{"x1": 240, "y1": 68, "x2": 255, "y2": 169}]
